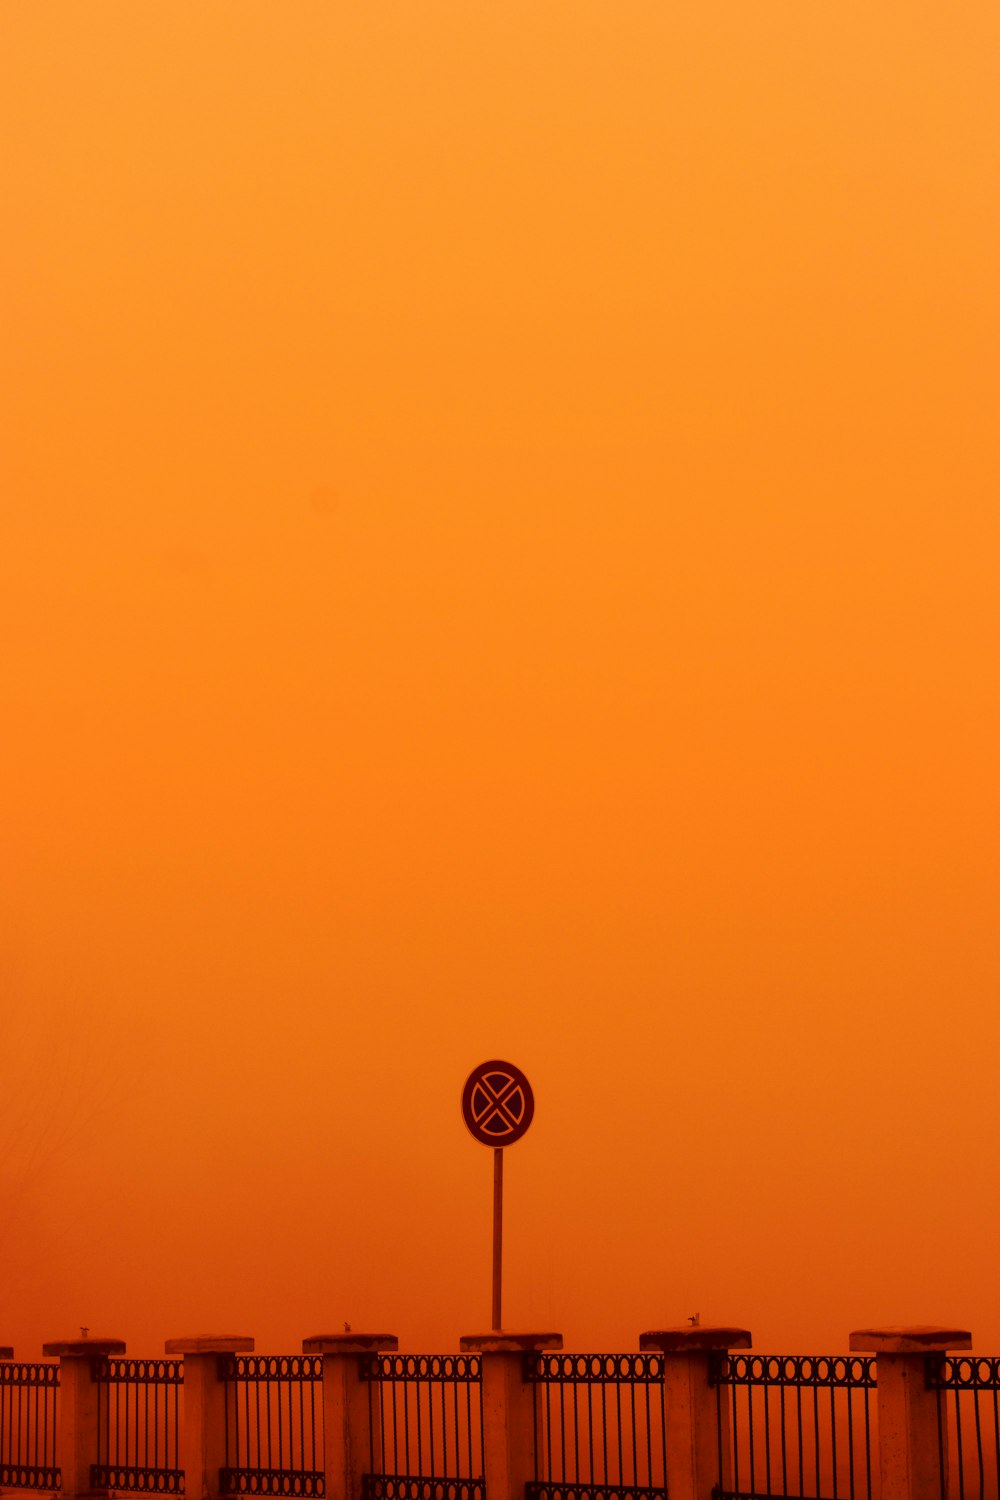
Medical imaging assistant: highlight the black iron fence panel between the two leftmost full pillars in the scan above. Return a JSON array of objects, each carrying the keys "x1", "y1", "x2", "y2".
[{"x1": 90, "y1": 1359, "x2": 184, "y2": 1494}]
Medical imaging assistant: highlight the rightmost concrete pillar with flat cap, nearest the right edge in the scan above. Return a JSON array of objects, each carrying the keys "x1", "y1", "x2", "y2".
[{"x1": 850, "y1": 1326, "x2": 972, "y2": 1500}]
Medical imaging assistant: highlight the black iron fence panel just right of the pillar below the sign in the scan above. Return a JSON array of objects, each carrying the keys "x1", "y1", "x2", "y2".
[{"x1": 525, "y1": 1353, "x2": 667, "y2": 1500}]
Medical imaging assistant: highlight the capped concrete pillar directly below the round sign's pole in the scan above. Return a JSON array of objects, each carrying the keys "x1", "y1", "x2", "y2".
[{"x1": 459, "y1": 1334, "x2": 562, "y2": 1500}]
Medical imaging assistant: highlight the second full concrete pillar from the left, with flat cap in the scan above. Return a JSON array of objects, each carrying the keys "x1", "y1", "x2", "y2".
[{"x1": 163, "y1": 1334, "x2": 253, "y2": 1500}]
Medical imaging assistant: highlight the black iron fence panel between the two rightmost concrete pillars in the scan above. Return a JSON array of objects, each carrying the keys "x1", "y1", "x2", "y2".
[{"x1": 712, "y1": 1355, "x2": 877, "y2": 1500}]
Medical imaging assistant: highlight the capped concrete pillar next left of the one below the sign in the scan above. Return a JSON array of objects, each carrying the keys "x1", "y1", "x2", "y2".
[{"x1": 301, "y1": 1334, "x2": 399, "y2": 1500}]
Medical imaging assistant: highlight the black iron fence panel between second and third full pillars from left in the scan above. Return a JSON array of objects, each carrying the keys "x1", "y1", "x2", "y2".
[{"x1": 219, "y1": 1355, "x2": 325, "y2": 1497}]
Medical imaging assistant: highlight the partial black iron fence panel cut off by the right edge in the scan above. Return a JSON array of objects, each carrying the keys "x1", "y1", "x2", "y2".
[{"x1": 928, "y1": 1355, "x2": 1000, "y2": 1500}]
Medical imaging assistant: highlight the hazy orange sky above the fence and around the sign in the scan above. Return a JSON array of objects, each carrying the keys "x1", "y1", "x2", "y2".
[{"x1": 0, "y1": 0, "x2": 1000, "y2": 1356}]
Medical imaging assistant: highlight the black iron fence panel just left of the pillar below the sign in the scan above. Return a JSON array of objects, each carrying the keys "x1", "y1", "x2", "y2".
[{"x1": 361, "y1": 1355, "x2": 486, "y2": 1500}]
